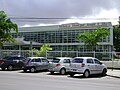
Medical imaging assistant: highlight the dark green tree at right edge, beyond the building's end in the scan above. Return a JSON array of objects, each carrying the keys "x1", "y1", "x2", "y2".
[{"x1": 113, "y1": 20, "x2": 120, "y2": 52}]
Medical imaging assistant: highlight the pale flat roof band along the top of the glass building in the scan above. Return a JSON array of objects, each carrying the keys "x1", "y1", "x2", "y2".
[{"x1": 13, "y1": 22, "x2": 112, "y2": 33}]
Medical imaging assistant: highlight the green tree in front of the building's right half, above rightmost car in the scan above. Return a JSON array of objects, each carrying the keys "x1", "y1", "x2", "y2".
[{"x1": 78, "y1": 28, "x2": 110, "y2": 51}]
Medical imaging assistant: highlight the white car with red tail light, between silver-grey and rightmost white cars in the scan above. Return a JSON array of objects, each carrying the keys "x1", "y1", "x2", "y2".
[{"x1": 48, "y1": 57, "x2": 72, "y2": 75}]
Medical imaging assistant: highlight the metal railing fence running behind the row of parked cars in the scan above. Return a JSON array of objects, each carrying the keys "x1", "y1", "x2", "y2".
[{"x1": 0, "y1": 50, "x2": 114, "y2": 60}]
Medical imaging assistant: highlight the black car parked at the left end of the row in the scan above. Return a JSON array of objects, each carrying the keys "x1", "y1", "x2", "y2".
[{"x1": 0, "y1": 56, "x2": 26, "y2": 71}]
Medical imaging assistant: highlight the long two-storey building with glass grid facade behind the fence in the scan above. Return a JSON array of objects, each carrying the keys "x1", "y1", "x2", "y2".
[{"x1": 4, "y1": 22, "x2": 113, "y2": 52}]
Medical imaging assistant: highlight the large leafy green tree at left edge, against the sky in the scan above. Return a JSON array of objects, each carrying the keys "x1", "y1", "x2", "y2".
[{"x1": 0, "y1": 11, "x2": 18, "y2": 46}]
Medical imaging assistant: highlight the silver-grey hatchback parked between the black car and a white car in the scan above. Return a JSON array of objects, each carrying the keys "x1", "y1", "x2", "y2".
[{"x1": 23, "y1": 57, "x2": 49, "y2": 73}]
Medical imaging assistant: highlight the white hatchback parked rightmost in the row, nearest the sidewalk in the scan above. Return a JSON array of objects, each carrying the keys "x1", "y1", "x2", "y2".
[{"x1": 69, "y1": 57, "x2": 107, "y2": 77}]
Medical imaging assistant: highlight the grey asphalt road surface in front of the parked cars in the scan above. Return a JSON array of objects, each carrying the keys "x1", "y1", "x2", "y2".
[{"x1": 0, "y1": 70, "x2": 120, "y2": 90}]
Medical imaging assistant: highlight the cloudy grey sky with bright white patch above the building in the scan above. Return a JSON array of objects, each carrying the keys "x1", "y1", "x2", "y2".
[{"x1": 0, "y1": 0, "x2": 120, "y2": 26}]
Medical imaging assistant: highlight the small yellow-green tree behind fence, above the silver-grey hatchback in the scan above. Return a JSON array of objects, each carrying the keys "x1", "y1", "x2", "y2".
[{"x1": 32, "y1": 44, "x2": 52, "y2": 57}]
